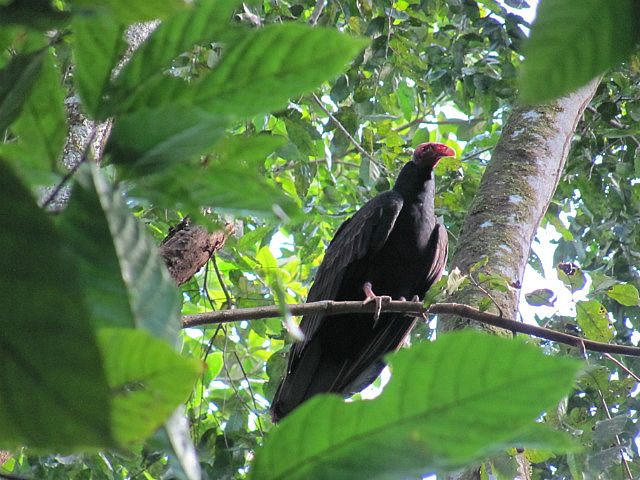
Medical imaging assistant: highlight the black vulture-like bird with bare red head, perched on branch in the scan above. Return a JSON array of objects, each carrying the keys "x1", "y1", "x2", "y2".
[{"x1": 270, "y1": 143, "x2": 455, "y2": 422}]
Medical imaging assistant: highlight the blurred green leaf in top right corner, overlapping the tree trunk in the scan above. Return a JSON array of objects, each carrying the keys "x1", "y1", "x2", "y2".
[{"x1": 520, "y1": 0, "x2": 640, "y2": 102}]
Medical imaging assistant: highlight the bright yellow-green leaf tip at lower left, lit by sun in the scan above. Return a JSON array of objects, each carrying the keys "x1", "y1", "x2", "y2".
[{"x1": 98, "y1": 328, "x2": 202, "y2": 445}]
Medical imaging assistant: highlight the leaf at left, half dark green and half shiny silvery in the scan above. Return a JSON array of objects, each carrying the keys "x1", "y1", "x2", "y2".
[{"x1": 60, "y1": 169, "x2": 180, "y2": 342}]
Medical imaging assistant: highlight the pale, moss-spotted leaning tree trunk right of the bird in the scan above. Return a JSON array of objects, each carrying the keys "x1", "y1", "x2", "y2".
[{"x1": 438, "y1": 79, "x2": 599, "y2": 335}]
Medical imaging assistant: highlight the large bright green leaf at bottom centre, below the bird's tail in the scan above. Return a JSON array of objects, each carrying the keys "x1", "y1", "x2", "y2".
[{"x1": 251, "y1": 331, "x2": 580, "y2": 480}]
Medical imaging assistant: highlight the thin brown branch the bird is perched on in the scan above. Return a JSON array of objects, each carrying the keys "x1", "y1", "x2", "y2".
[{"x1": 182, "y1": 300, "x2": 640, "y2": 357}]
